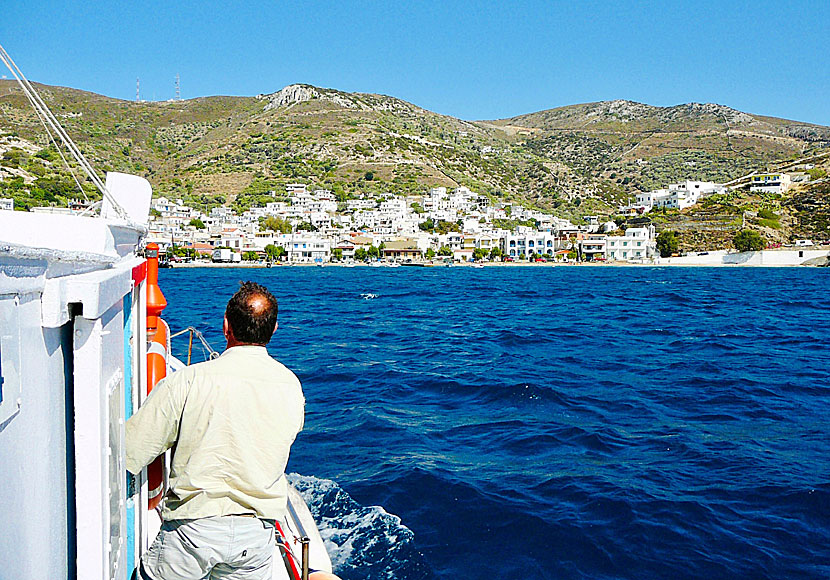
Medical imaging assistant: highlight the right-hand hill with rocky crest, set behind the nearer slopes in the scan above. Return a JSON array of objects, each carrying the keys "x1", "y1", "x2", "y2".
[{"x1": 492, "y1": 101, "x2": 830, "y2": 196}]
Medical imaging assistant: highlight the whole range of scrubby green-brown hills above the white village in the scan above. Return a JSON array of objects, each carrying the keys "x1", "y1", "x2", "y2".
[{"x1": 0, "y1": 81, "x2": 830, "y2": 245}]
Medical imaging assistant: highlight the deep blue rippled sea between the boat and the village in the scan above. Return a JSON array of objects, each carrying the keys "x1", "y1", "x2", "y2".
[{"x1": 161, "y1": 267, "x2": 830, "y2": 580}]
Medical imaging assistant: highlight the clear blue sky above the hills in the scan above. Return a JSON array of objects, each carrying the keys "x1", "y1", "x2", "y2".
[{"x1": 0, "y1": 0, "x2": 830, "y2": 125}]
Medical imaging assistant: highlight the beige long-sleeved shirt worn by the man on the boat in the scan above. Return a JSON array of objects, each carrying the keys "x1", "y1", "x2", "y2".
[{"x1": 126, "y1": 346, "x2": 305, "y2": 520}]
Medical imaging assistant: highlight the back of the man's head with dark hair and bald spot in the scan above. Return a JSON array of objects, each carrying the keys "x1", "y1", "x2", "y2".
[{"x1": 225, "y1": 282, "x2": 277, "y2": 344}]
